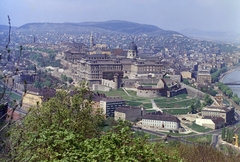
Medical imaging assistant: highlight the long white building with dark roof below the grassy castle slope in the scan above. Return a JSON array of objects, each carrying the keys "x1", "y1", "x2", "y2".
[{"x1": 142, "y1": 112, "x2": 180, "y2": 131}]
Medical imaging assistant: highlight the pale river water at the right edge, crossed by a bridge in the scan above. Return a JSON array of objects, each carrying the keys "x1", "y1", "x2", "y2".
[{"x1": 222, "y1": 69, "x2": 240, "y2": 97}]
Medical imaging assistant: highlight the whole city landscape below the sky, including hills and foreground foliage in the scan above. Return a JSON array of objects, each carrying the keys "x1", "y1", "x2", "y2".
[{"x1": 0, "y1": 0, "x2": 240, "y2": 162}]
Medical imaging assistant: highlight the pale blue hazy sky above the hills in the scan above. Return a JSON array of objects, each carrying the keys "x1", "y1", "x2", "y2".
[{"x1": 0, "y1": 0, "x2": 240, "y2": 33}]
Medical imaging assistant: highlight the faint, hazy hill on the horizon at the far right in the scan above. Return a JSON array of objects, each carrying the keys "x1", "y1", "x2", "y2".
[{"x1": 179, "y1": 28, "x2": 240, "y2": 43}]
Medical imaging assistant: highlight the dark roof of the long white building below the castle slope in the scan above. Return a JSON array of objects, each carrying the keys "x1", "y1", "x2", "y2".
[{"x1": 142, "y1": 113, "x2": 180, "y2": 123}]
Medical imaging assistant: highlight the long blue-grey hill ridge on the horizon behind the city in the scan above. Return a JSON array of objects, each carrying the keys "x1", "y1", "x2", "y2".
[{"x1": 18, "y1": 20, "x2": 179, "y2": 35}]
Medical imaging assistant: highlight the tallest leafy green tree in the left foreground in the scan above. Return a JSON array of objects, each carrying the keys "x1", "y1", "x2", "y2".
[{"x1": 8, "y1": 85, "x2": 103, "y2": 161}]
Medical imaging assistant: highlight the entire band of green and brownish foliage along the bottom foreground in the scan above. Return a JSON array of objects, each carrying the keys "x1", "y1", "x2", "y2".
[{"x1": 0, "y1": 86, "x2": 239, "y2": 162}]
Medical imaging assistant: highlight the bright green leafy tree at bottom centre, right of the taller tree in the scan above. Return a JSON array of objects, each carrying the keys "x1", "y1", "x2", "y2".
[{"x1": 73, "y1": 122, "x2": 180, "y2": 162}]
